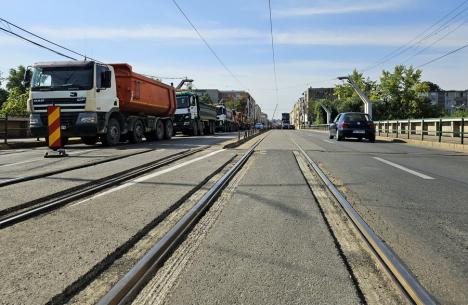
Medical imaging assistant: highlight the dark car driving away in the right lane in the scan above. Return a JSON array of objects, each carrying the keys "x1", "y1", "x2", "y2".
[{"x1": 329, "y1": 112, "x2": 375, "y2": 142}]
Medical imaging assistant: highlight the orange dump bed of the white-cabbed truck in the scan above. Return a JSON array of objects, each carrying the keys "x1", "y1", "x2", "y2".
[{"x1": 110, "y1": 64, "x2": 176, "y2": 117}]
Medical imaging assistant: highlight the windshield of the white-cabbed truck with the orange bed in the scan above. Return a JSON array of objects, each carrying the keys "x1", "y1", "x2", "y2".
[{"x1": 31, "y1": 66, "x2": 93, "y2": 91}]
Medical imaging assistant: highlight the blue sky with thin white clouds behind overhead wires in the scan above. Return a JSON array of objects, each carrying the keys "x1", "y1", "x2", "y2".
[{"x1": 0, "y1": 0, "x2": 468, "y2": 117}]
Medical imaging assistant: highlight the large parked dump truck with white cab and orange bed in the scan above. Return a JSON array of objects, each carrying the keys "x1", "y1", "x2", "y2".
[{"x1": 26, "y1": 61, "x2": 176, "y2": 145}]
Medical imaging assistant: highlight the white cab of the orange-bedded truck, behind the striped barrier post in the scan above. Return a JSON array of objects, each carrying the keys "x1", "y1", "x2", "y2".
[{"x1": 28, "y1": 61, "x2": 119, "y2": 142}]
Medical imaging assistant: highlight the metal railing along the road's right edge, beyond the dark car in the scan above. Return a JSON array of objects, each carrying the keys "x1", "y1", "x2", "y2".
[{"x1": 309, "y1": 118, "x2": 468, "y2": 144}]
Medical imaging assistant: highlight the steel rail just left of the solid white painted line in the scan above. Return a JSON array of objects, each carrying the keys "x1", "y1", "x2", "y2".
[{"x1": 0, "y1": 147, "x2": 208, "y2": 229}]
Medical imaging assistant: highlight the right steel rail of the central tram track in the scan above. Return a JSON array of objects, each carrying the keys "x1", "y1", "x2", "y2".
[{"x1": 292, "y1": 140, "x2": 437, "y2": 305}]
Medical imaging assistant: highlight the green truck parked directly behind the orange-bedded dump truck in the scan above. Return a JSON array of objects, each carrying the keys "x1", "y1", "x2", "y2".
[{"x1": 174, "y1": 91, "x2": 216, "y2": 136}]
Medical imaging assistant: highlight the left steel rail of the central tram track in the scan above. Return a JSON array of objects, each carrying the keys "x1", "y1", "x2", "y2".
[{"x1": 97, "y1": 139, "x2": 263, "y2": 305}]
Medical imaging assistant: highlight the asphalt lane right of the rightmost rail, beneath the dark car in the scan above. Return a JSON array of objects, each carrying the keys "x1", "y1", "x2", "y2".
[{"x1": 291, "y1": 131, "x2": 468, "y2": 304}]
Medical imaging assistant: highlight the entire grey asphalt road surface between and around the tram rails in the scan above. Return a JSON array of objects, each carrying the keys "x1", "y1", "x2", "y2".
[{"x1": 0, "y1": 130, "x2": 468, "y2": 304}]
